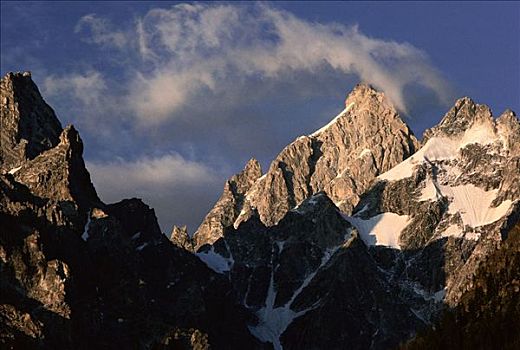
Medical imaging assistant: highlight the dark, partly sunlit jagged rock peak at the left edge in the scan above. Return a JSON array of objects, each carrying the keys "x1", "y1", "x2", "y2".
[{"x1": 0, "y1": 73, "x2": 100, "y2": 229}]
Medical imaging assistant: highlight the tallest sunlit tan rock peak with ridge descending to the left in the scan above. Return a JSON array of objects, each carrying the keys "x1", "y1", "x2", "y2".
[{"x1": 194, "y1": 84, "x2": 419, "y2": 248}]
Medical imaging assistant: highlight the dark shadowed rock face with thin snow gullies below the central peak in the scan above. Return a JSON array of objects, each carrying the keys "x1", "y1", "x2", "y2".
[{"x1": 197, "y1": 193, "x2": 424, "y2": 349}]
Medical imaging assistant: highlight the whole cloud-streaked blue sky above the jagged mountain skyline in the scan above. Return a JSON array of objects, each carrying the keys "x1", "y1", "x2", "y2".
[{"x1": 1, "y1": 1, "x2": 520, "y2": 231}]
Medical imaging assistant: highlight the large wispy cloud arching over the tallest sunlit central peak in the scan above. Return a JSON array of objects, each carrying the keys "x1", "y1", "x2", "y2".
[{"x1": 75, "y1": 4, "x2": 451, "y2": 124}]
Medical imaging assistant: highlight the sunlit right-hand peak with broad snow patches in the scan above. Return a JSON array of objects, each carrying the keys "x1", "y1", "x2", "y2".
[{"x1": 354, "y1": 98, "x2": 520, "y2": 306}]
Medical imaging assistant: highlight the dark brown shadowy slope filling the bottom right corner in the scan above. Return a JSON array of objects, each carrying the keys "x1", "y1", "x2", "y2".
[{"x1": 401, "y1": 224, "x2": 520, "y2": 350}]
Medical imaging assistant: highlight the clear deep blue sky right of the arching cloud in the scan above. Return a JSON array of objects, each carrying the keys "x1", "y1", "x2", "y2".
[{"x1": 283, "y1": 1, "x2": 520, "y2": 112}]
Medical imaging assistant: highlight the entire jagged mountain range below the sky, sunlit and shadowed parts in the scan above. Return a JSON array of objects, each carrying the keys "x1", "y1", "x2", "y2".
[{"x1": 0, "y1": 73, "x2": 520, "y2": 349}]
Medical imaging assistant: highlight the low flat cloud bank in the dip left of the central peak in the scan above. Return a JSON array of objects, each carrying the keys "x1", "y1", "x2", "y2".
[{"x1": 86, "y1": 153, "x2": 223, "y2": 233}]
